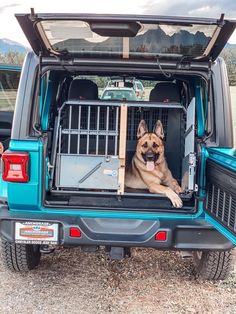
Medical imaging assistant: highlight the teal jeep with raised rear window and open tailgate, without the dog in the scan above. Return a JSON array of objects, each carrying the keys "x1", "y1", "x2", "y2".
[{"x1": 0, "y1": 10, "x2": 236, "y2": 280}]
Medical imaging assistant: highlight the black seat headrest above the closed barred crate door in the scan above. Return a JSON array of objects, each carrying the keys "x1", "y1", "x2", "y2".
[{"x1": 68, "y1": 79, "x2": 98, "y2": 100}]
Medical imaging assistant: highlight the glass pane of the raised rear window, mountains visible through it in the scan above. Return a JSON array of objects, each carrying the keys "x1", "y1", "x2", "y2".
[{"x1": 37, "y1": 20, "x2": 217, "y2": 59}]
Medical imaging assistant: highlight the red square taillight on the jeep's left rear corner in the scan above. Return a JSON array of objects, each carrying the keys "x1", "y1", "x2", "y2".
[{"x1": 2, "y1": 151, "x2": 29, "y2": 182}]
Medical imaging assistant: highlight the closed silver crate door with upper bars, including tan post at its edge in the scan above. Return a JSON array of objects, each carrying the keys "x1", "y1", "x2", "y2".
[{"x1": 56, "y1": 104, "x2": 127, "y2": 194}]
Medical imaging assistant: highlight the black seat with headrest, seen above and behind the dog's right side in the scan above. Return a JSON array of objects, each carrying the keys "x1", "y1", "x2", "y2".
[{"x1": 149, "y1": 82, "x2": 185, "y2": 181}]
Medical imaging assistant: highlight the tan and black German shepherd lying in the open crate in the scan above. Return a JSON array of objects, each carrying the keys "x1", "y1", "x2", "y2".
[{"x1": 125, "y1": 120, "x2": 183, "y2": 207}]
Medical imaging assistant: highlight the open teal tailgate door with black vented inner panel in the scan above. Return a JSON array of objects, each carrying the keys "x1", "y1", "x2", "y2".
[{"x1": 206, "y1": 148, "x2": 236, "y2": 245}]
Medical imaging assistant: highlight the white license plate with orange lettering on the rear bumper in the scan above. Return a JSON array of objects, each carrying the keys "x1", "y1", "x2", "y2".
[{"x1": 15, "y1": 221, "x2": 58, "y2": 244}]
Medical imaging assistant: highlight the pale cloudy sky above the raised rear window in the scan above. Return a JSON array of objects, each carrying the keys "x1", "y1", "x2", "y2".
[{"x1": 0, "y1": 0, "x2": 236, "y2": 46}]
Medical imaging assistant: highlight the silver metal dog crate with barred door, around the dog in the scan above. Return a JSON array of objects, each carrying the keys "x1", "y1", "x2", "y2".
[{"x1": 51, "y1": 99, "x2": 195, "y2": 194}]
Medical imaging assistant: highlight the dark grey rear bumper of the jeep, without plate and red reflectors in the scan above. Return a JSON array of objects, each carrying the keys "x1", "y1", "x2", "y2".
[{"x1": 0, "y1": 205, "x2": 233, "y2": 250}]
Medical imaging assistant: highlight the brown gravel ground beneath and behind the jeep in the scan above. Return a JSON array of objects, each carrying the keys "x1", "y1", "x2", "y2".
[{"x1": 0, "y1": 248, "x2": 236, "y2": 314}]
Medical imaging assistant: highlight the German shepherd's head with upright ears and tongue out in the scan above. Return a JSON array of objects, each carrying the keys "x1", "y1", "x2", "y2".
[{"x1": 136, "y1": 120, "x2": 164, "y2": 171}]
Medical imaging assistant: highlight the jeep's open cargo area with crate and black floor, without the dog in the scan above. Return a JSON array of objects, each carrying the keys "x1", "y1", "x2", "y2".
[{"x1": 45, "y1": 72, "x2": 202, "y2": 212}]
